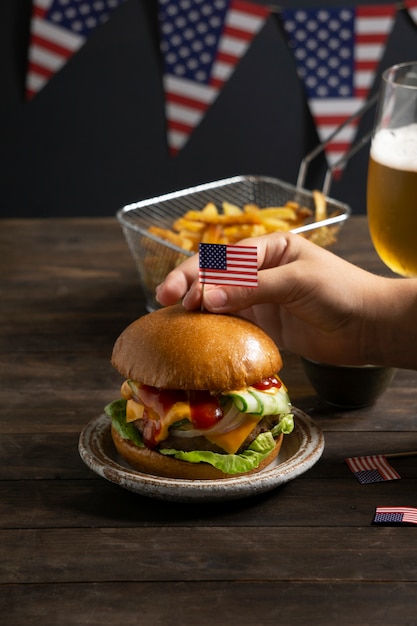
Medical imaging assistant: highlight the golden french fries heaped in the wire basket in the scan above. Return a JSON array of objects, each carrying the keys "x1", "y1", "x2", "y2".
[{"x1": 148, "y1": 191, "x2": 335, "y2": 252}]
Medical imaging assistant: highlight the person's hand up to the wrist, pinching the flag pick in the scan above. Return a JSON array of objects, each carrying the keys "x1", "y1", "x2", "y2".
[{"x1": 157, "y1": 233, "x2": 386, "y2": 364}]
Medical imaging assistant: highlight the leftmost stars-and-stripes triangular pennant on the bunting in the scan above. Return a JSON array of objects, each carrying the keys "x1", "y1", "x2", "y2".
[{"x1": 26, "y1": 0, "x2": 125, "y2": 99}]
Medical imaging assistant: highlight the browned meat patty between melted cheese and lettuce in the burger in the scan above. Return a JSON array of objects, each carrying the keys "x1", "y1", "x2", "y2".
[{"x1": 134, "y1": 415, "x2": 279, "y2": 454}]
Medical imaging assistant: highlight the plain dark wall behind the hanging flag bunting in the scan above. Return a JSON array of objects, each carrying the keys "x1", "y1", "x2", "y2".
[{"x1": 0, "y1": 0, "x2": 417, "y2": 217}]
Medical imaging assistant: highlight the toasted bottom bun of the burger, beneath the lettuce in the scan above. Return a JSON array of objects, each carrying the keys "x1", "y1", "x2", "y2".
[{"x1": 111, "y1": 425, "x2": 283, "y2": 480}]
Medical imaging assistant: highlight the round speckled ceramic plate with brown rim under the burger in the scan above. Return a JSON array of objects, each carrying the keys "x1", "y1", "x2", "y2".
[{"x1": 79, "y1": 407, "x2": 324, "y2": 502}]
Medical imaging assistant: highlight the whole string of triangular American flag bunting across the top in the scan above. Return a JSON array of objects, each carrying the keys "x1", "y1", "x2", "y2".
[{"x1": 26, "y1": 0, "x2": 417, "y2": 173}]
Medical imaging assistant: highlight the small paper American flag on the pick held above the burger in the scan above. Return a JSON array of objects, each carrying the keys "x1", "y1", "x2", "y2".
[{"x1": 199, "y1": 243, "x2": 258, "y2": 287}]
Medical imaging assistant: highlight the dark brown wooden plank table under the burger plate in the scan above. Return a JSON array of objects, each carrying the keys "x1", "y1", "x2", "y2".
[{"x1": 0, "y1": 217, "x2": 417, "y2": 626}]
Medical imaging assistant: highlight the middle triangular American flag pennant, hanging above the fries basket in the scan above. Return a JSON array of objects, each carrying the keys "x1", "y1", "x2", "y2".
[{"x1": 158, "y1": 0, "x2": 269, "y2": 155}]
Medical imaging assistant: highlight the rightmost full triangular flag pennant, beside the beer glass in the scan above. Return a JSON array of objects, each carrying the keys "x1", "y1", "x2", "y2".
[{"x1": 282, "y1": 4, "x2": 396, "y2": 173}]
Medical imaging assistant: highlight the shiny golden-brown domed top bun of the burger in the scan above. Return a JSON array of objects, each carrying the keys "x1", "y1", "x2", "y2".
[{"x1": 112, "y1": 304, "x2": 282, "y2": 391}]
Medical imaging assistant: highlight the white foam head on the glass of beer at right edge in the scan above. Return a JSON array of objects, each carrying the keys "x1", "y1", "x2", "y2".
[{"x1": 371, "y1": 124, "x2": 417, "y2": 172}]
